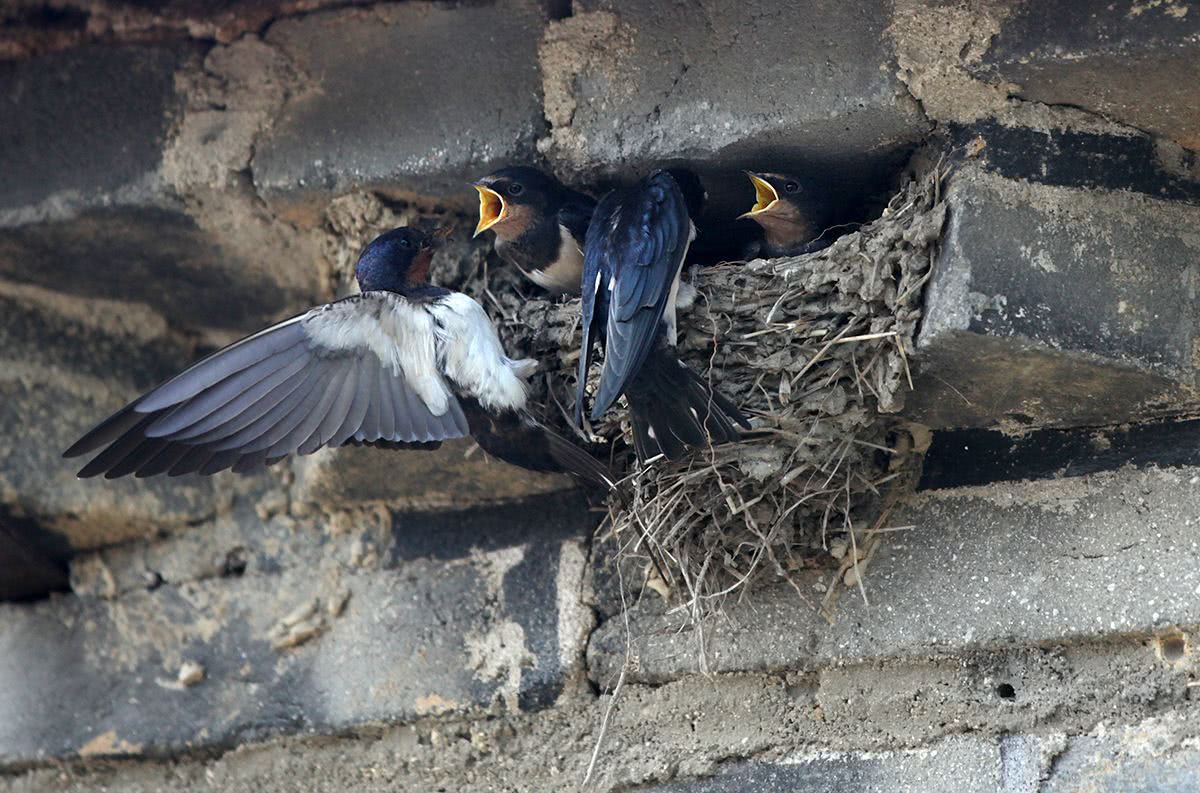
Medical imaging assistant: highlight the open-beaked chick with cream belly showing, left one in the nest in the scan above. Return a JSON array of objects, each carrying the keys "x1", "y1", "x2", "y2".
[{"x1": 475, "y1": 166, "x2": 596, "y2": 295}]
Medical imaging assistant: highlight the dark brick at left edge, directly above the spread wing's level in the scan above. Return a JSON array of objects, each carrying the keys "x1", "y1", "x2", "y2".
[{"x1": 0, "y1": 42, "x2": 317, "y2": 331}]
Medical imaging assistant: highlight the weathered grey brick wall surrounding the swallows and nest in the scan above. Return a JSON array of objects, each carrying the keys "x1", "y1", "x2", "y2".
[{"x1": 0, "y1": 0, "x2": 1200, "y2": 793}]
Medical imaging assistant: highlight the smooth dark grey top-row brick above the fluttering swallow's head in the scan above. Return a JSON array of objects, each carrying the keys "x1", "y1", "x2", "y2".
[{"x1": 253, "y1": 0, "x2": 545, "y2": 220}]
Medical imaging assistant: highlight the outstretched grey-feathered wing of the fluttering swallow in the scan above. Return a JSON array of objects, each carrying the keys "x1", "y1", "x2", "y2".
[{"x1": 65, "y1": 292, "x2": 470, "y2": 479}]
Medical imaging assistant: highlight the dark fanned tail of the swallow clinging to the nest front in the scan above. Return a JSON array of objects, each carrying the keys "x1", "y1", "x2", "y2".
[{"x1": 625, "y1": 348, "x2": 750, "y2": 461}]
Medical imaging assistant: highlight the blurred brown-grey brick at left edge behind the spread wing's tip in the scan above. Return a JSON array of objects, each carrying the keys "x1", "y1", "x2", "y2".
[{"x1": 0, "y1": 290, "x2": 264, "y2": 549}]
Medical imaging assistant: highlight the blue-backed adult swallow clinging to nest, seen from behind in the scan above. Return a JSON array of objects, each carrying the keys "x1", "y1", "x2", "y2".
[{"x1": 575, "y1": 169, "x2": 750, "y2": 462}]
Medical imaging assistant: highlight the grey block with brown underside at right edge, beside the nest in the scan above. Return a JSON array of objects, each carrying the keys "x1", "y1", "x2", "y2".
[{"x1": 906, "y1": 128, "x2": 1200, "y2": 429}]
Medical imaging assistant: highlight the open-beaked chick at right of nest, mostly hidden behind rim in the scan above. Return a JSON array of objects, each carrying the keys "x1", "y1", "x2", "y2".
[{"x1": 740, "y1": 170, "x2": 832, "y2": 258}]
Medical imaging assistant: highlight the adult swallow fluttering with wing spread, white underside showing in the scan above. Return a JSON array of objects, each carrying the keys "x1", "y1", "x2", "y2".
[{"x1": 65, "y1": 228, "x2": 608, "y2": 485}]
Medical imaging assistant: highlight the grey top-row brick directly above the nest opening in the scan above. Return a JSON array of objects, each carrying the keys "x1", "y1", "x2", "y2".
[{"x1": 542, "y1": 0, "x2": 928, "y2": 199}]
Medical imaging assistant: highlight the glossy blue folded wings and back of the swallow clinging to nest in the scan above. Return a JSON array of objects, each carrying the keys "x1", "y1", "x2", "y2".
[{"x1": 584, "y1": 172, "x2": 691, "y2": 419}]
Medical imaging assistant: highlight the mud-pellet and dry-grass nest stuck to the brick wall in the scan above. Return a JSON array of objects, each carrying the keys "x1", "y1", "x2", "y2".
[{"x1": 319, "y1": 168, "x2": 946, "y2": 617}]
